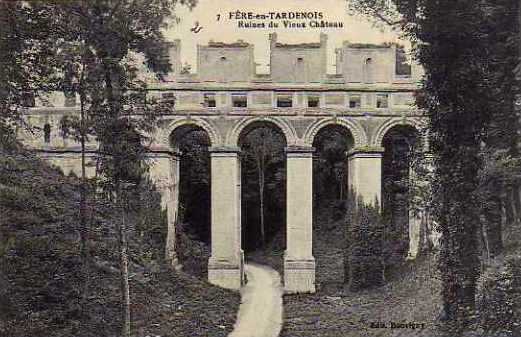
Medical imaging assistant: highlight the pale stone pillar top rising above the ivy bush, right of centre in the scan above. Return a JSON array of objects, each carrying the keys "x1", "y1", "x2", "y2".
[{"x1": 348, "y1": 148, "x2": 383, "y2": 206}]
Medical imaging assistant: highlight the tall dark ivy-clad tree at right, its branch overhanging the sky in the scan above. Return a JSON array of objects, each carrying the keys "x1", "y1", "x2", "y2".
[{"x1": 352, "y1": 0, "x2": 518, "y2": 329}]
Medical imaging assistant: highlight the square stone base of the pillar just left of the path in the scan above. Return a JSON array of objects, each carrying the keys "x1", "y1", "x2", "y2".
[{"x1": 208, "y1": 258, "x2": 244, "y2": 290}]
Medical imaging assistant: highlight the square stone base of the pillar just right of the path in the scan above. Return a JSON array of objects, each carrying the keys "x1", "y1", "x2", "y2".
[{"x1": 284, "y1": 256, "x2": 315, "y2": 294}]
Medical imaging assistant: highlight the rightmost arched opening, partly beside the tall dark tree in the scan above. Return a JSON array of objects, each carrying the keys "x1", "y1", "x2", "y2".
[{"x1": 382, "y1": 125, "x2": 420, "y2": 264}]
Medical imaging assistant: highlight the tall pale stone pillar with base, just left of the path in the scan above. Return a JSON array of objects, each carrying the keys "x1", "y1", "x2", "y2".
[{"x1": 208, "y1": 147, "x2": 244, "y2": 289}]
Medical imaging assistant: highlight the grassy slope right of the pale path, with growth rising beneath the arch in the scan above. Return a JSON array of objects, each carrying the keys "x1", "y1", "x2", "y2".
[{"x1": 281, "y1": 202, "x2": 440, "y2": 337}]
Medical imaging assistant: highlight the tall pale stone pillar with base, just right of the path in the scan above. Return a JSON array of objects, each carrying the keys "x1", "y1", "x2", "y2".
[{"x1": 284, "y1": 147, "x2": 315, "y2": 293}]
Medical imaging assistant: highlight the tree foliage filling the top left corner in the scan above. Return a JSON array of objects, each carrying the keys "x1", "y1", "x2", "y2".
[{"x1": 0, "y1": 1, "x2": 55, "y2": 146}]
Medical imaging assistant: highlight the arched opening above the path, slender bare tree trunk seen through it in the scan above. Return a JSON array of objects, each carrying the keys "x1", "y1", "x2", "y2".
[{"x1": 238, "y1": 121, "x2": 286, "y2": 270}]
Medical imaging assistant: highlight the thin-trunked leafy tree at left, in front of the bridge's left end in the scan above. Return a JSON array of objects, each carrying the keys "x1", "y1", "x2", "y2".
[{"x1": 39, "y1": 0, "x2": 193, "y2": 336}]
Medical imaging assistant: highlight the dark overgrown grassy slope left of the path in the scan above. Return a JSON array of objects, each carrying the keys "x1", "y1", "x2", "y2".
[{"x1": 0, "y1": 146, "x2": 239, "y2": 337}]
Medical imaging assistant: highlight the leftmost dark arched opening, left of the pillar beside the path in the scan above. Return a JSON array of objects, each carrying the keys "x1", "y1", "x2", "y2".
[{"x1": 170, "y1": 125, "x2": 211, "y2": 278}]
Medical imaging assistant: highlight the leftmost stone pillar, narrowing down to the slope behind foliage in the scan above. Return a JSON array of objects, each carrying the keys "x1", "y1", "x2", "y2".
[{"x1": 149, "y1": 151, "x2": 180, "y2": 266}]
